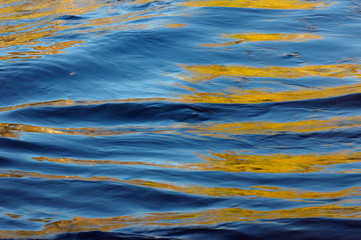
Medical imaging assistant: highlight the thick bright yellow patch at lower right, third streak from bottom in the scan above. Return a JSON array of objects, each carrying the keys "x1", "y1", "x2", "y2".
[{"x1": 192, "y1": 151, "x2": 361, "y2": 173}]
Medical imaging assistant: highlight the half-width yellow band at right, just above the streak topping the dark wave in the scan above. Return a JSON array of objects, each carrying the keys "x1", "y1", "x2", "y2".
[{"x1": 182, "y1": 64, "x2": 361, "y2": 82}]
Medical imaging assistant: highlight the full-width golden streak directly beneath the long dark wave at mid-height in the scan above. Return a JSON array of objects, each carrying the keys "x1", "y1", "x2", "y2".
[{"x1": 0, "y1": 113, "x2": 361, "y2": 139}]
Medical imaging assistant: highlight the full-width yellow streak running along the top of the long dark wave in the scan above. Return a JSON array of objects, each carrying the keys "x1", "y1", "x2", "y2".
[{"x1": 0, "y1": 84, "x2": 361, "y2": 112}]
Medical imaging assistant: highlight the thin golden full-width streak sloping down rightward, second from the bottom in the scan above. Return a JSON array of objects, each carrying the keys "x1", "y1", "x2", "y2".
[{"x1": 7, "y1": 166, "x2": 361, "y2": 201}]
